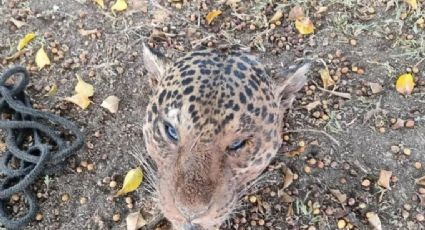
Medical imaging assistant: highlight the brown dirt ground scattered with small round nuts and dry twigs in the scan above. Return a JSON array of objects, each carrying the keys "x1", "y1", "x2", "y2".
[{"x1": 0, "y1": 0, "x2": 425, "y2": 230}]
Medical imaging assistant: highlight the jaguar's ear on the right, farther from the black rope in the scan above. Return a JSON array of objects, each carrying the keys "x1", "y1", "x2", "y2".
[{"x1": 274, "y1": 63, "x2": 310, "y2": 111}]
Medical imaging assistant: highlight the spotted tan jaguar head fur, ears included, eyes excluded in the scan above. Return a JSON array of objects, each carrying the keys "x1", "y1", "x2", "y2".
[{"x1": 143, "y1": 46, "x2": 308, "y2": 229}]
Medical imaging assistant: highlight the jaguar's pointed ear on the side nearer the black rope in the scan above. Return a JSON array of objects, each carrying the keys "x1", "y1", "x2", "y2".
[{"x1": 143, "y1": 43, "x2": 170, "y2": 83}]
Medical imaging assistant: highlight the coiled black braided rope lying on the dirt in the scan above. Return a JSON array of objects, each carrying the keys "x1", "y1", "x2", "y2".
[{"x1": 0, "y1": 66, "x2": 84, "y2": 229}]
